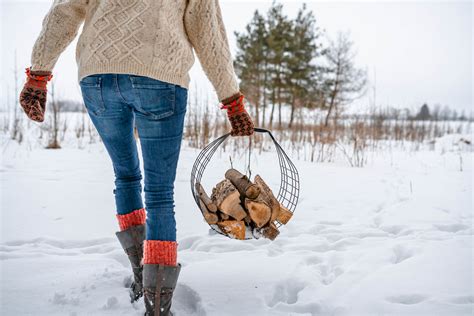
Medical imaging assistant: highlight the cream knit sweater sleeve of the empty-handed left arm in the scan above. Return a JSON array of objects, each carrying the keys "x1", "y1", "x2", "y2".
[{"x1": 31, "y1": 0, "x2": 88, "y2": 71}]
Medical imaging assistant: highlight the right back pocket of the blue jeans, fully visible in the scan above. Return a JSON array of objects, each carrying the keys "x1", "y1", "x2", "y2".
[{"x1": 130, "y1": 76, "x2": 176, "y2": 120}]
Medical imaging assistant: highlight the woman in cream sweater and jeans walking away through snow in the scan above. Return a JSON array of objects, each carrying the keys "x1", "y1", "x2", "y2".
[{"x1": 20, "y1": 0, "x2": 254, "y2": 315}]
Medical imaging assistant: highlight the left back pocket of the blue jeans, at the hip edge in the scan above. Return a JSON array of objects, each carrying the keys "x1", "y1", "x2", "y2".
[{"x1": 79, "y1": 75, "x2": 105, "y2": 115}]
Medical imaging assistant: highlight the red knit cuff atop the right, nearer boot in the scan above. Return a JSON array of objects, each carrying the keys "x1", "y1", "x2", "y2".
[{"x1": 143, "y1": 240, "x2": 178, "y2": 266}]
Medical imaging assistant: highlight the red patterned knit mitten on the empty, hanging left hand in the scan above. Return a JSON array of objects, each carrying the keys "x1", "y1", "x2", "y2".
[{"x1": 20, "y1": 68, "x2": 53, "y2": 122}]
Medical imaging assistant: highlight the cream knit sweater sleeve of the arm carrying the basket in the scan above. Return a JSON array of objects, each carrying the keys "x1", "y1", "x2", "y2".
[{"x1": 184, "y1": 0, "x2": 239, "y2": 101}]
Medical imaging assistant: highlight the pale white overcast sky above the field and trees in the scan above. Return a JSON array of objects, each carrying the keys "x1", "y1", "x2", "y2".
[{"x1": 0, "y1": 0, "x2": 474, "y2": 111}]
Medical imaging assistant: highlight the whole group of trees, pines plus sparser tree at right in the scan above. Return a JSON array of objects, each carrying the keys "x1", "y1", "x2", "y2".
[{"x1": 234, "y1": 2, "x2": 367, "y2": 128}]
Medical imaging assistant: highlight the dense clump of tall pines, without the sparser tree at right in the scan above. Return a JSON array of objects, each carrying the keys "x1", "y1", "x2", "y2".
[{"x1": 234, "y1": 1, "x2": 336, "y2": 128}]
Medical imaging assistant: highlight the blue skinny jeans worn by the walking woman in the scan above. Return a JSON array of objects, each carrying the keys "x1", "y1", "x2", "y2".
[{"x1": 79, "y1": 74, "x2": 188, "y2": 241}]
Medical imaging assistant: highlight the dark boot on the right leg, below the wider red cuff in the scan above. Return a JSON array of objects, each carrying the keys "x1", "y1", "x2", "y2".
[{"x1": 143, "y1": 263, "x2": 181, "y2": 316}]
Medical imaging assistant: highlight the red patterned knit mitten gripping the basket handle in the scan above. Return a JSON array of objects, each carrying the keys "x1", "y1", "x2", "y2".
[{"x1": 221, "y1": 92, "x2": 254, "y2": 136}]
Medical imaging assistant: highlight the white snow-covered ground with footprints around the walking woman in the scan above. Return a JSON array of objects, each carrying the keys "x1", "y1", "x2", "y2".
[{"x1": 0, "y1": 122, "x2": 474, "y2": 316}]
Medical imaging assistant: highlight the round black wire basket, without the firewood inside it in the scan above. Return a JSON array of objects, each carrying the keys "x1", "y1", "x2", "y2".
[{"x1": 191, "y1": 128, "x2": 300, "y2": 239}]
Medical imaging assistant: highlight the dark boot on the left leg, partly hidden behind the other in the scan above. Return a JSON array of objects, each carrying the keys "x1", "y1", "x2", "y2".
[{"x1": 115, "y1": 225, "x2": 145, "y2": 303}]
